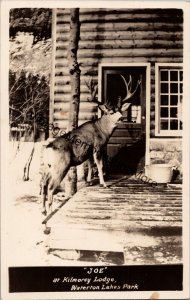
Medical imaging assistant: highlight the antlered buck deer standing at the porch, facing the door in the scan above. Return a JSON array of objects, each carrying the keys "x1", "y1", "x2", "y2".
[{"x1": 41, "y1": 75, "x2": 141, "y2": 215}]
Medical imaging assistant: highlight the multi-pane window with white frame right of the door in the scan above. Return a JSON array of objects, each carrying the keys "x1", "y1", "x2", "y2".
[{"x1": 156, "y1": 64, "x2": 183, "y2": 136}]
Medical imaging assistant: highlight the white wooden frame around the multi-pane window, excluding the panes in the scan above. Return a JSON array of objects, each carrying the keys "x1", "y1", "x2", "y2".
[{"x1": 155, "y1": 63, "x2": 183, "y2": 137}]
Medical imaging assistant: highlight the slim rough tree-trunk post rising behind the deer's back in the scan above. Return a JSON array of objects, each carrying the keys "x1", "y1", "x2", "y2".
[{"x1": 65, "y1": 8, "x2": 80, "y2": 196}]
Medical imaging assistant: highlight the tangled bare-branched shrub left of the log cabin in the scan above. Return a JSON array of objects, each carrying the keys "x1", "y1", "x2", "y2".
[{"x1": 9, "y1": 70, "x2": 49, "y2": 141}]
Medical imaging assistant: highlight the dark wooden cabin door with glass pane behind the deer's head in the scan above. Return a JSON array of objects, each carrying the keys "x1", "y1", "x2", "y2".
[{"x1": 102, "y1": 67, "x2": 146, "y2": 174}]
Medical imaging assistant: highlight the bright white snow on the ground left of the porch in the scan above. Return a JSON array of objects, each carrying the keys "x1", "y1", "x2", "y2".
[{"x1": 6, "y1": 142, "x2": 98, "y2": 266}]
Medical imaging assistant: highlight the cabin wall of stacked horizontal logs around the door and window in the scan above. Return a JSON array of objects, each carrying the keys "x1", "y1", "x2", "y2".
[{"x1": 51, "y1": 8, "x2": 183, "y2": 176}]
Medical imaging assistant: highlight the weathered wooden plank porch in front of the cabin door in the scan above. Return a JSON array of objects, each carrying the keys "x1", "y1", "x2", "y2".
[{"x1": 46, "y1": 176, "x2": 182, "y2": 265}]
